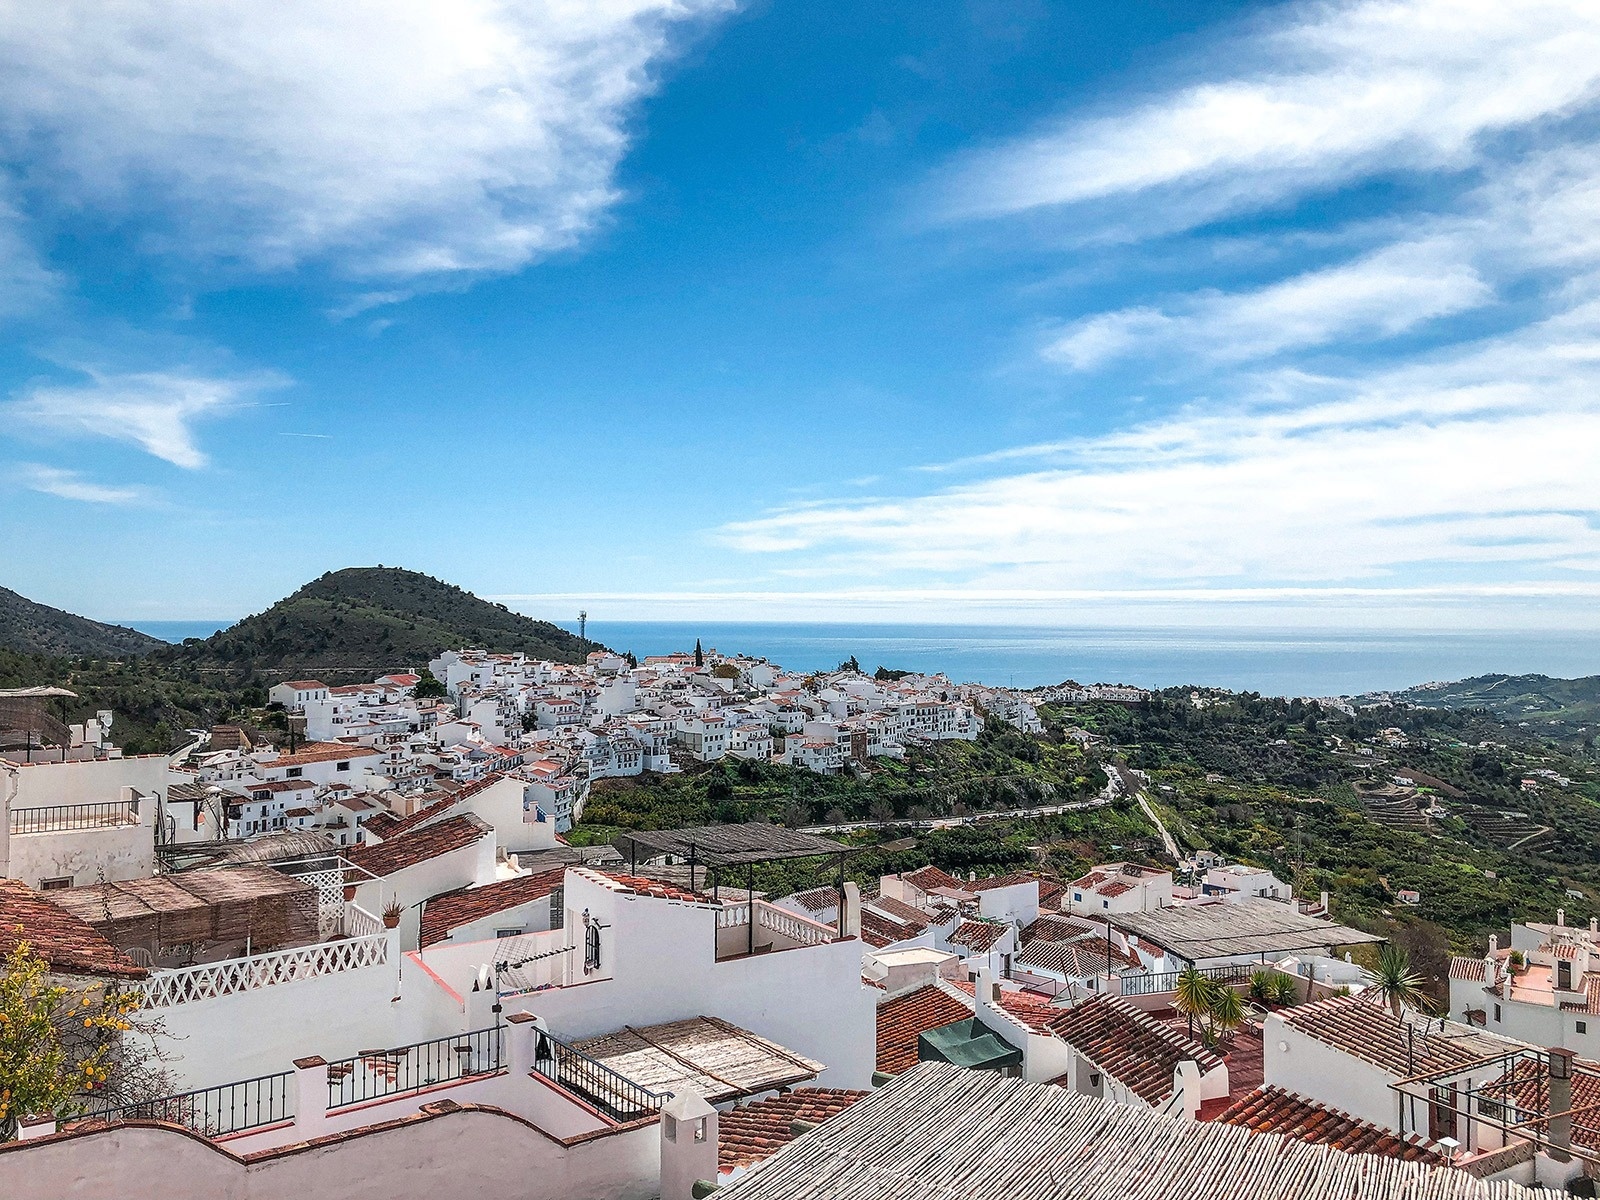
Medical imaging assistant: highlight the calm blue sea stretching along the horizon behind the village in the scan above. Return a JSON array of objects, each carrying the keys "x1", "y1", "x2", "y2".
[{"x1": 120, "y1": 621, "x2": 1600, "y2": 696}]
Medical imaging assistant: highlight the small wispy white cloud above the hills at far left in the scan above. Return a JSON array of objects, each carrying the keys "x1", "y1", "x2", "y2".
[{"x1": 3, "y1": 368, "x2": 283, "y2": 470}]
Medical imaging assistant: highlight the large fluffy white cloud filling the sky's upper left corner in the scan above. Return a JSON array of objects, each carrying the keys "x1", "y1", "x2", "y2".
[{"x1": 0, "y1": 0, "x2": 730, "y2": 280}]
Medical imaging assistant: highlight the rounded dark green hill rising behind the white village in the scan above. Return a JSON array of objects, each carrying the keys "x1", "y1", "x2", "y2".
[{"x1": 155, "y1": 566, "x2": 600, "y2": 683}]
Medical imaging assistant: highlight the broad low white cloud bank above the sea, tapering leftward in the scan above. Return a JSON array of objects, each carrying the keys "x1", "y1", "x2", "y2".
[{"x1": 720, "y1": 304, "x2": 1600, "y2": 589}]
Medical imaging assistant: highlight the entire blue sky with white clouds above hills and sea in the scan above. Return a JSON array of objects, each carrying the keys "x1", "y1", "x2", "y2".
[{"x1": 0, "y1": 0, "x2": 1600, "y2": 627}]
